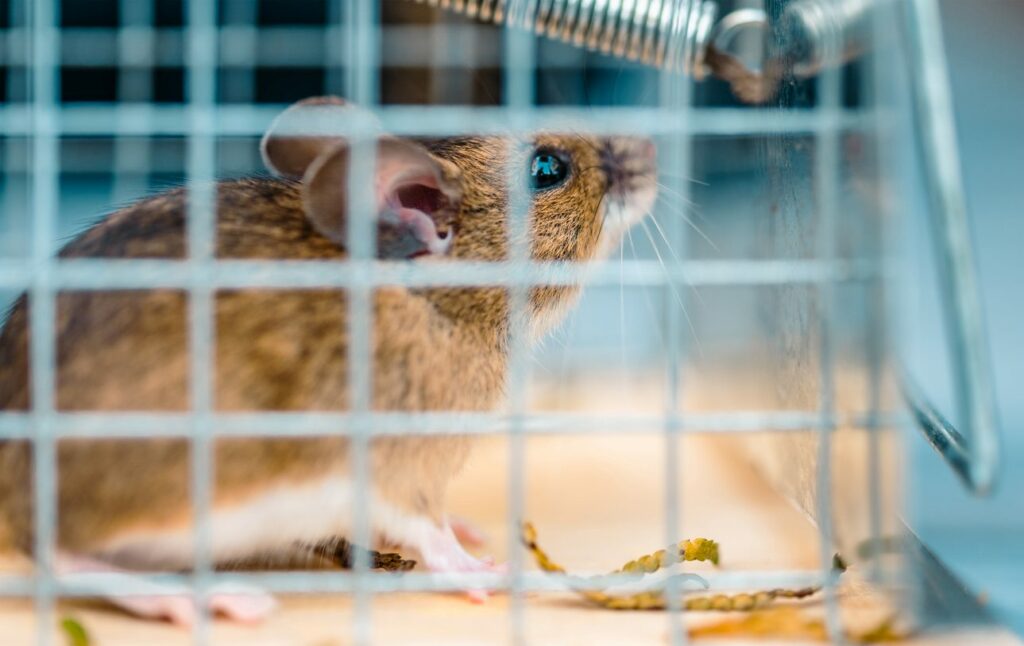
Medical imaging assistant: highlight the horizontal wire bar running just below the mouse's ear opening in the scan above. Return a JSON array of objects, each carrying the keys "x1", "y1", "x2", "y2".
[{"x1": 0, "y1": 259, "x2": 879, "y2": 291}]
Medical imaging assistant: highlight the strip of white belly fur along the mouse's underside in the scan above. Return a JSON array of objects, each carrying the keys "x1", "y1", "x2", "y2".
[{"x1": 95, "y1": 476, "x2": 437, "y2": 569}]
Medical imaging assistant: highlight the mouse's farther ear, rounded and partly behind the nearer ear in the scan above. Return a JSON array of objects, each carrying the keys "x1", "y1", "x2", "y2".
[{"x1": 260, "y1": 96, "x2": 380, "y2": 179}]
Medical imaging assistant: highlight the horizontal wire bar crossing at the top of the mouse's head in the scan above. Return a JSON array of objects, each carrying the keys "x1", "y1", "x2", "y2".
[{"x1": 0, "y1": 102, "x2": 892, "y2": 137}]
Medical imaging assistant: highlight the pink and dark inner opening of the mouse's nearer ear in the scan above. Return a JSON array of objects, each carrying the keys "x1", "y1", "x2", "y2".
[{"x1": 377, "y1": 174, "x2": 459, "y2": 259}]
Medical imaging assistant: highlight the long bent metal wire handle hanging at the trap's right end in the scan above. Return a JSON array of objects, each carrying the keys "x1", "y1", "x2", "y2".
[{"x1": 902, "y1": 0, "x2": 999, "y2": 494}]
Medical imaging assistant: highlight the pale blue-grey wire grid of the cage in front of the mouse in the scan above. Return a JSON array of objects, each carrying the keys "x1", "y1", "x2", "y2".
[{"x1": 0, "y1": 0, "x2": 897, "y2": 644}]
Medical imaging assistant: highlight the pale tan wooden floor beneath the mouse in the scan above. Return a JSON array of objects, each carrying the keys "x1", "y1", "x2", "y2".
[{"x1": 0, "y1": 376, "x2": 1020, "y2": 646}]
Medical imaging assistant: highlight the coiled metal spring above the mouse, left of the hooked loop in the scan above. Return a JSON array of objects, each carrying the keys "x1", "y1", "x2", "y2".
[{"x1": 418, "y1": 0, "x2": 718, "y2": 80}]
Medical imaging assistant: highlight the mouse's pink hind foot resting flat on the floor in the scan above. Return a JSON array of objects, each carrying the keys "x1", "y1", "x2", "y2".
[{"x1": 54, "y1": 552, "x2": 276, "y2": 626}]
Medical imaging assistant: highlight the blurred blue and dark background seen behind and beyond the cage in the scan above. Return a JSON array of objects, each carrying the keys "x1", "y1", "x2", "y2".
[{"x1": 0, "y1": 0, "x2": 1024, "y2": 631}]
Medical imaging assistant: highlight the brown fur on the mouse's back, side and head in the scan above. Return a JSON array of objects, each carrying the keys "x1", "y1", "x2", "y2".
[{"x1": 0, "y1": 101, "x2": 655, "y2": 565}]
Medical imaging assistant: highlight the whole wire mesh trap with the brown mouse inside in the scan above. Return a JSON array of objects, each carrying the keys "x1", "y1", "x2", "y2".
[{"x1": 0, "y1": 0, "x2": 991, "y2": 644}]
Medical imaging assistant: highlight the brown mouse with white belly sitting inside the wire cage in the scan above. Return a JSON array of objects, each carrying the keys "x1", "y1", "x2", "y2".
[{"x1": 0, "y1": 96, "x2": 657, "y2": 625}]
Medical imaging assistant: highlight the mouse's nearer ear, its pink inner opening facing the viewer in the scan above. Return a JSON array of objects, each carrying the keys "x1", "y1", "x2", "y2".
[{"x1": 303, "y1": 137, "x2": 462, "y2": 258}]
